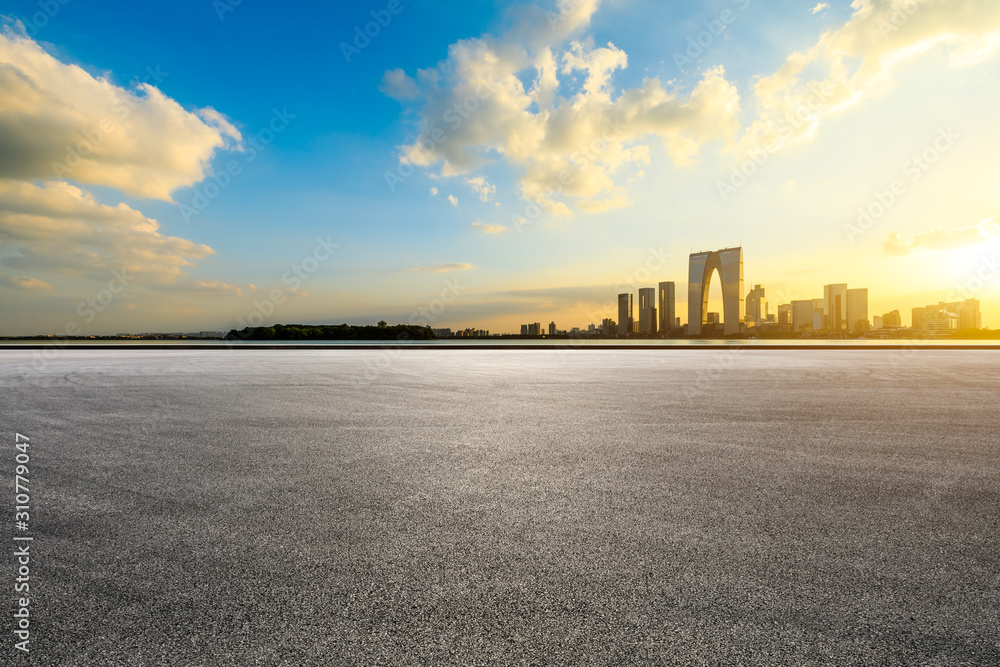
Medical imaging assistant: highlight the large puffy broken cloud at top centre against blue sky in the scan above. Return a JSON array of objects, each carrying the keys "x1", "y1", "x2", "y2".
[{"x1": 382, "y1": 0, "x2": 739, "y2": 217}]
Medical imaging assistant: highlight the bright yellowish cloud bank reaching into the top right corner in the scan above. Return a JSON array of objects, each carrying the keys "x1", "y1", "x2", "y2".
[{"x1": 737, "y1": 0, "x2": 1000, "y2": 155}]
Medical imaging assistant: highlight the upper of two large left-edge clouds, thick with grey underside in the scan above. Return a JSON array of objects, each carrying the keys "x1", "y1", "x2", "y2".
[{"x1": 0, "y1": 26, "x2": 242, "y2": 201}]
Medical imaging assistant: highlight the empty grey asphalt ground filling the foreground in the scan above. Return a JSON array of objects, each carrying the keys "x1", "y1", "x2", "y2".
[{"x1": 0, "y1": 349, "x2": 1000, "y2": 666}]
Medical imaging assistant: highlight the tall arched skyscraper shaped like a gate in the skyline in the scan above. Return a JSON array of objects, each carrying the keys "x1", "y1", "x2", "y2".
[{"x1": 688, "y1": 247, "x2": 744, "y2": 336}]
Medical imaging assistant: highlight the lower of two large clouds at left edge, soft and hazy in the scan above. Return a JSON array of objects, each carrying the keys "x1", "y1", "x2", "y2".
[{"x1": 0, "y1": 180, "x2": 215, "y2": 284}]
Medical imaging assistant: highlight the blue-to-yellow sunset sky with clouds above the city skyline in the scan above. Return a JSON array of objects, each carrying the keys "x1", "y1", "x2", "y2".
[{"x1": 0, "y1": 0, "x2": 1000, "y2": 336}]
